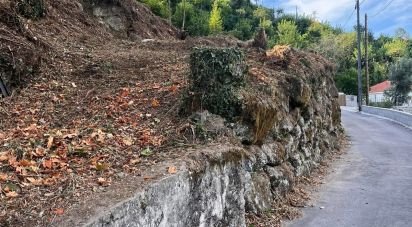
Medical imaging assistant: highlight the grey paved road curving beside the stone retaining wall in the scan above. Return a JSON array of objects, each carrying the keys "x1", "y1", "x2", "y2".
[{"x1": 287, "y1": 111, "x2": 412, "y2": 227}]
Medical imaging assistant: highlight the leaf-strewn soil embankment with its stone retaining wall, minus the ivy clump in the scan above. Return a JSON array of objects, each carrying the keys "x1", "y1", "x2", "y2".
[{"x1": 0, "y1": 0, "x2": 341, "y2": 226}]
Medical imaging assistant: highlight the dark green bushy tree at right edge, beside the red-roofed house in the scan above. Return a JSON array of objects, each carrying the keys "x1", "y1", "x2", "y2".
[{"x1": 387, "y1": 58, "x2": 412, "y2": 105}]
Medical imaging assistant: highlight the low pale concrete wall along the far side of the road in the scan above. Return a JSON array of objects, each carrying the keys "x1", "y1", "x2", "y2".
[{"x1": 362, "y1": 106, "x2": 412, "y2": 127}]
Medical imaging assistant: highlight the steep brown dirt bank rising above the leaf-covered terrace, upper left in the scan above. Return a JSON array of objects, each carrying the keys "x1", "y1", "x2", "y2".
[{"x1": 0, "y1": 0, "x2": 178, "y2": 91}]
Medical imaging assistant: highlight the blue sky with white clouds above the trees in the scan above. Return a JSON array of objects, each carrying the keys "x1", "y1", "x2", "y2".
[{"x1": 262, "y1": 0, "x2": 412, "y2": 37}]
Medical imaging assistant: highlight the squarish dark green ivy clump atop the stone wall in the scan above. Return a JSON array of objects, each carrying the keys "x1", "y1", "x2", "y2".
[{"x1": 183, "y1": 48, "x2": 246, "y2": 119}]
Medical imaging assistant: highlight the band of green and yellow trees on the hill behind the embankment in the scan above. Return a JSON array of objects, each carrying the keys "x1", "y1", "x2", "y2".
[{"x1": 140, "y1": 0, "x2": 412, "y2": 100}]
